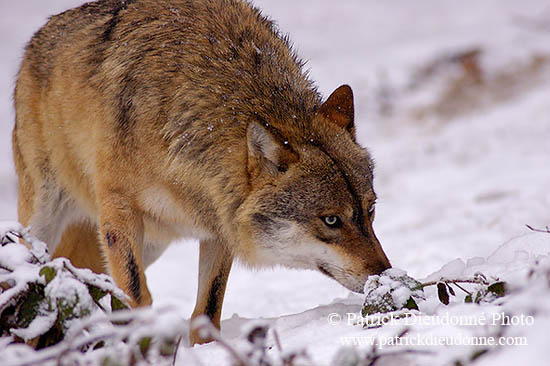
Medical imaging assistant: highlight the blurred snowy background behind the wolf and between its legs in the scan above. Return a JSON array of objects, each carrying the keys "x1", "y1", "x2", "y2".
[{"x1": 0, "y1": 0, "x2": 550, "y2": 318}]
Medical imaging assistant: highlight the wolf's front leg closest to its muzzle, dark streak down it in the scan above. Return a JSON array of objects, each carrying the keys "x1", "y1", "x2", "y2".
[{"x1": 189, "y1": 239, "x2": 233, "y2": 345}]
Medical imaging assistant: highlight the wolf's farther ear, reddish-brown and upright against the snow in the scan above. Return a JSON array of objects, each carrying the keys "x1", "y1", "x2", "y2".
[{"x1": 319, "y1": 85, "x2": 355, "y2": 135}]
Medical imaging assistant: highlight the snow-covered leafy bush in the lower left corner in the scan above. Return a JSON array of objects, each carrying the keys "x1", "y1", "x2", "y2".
[{"x1": 0, "y1": 223, "x2": 187, "y2": 366}]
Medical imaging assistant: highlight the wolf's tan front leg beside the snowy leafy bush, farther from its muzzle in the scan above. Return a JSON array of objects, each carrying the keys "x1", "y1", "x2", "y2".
[{"x1": 100, "y1": 193, "x2": 152, "y2": 307}]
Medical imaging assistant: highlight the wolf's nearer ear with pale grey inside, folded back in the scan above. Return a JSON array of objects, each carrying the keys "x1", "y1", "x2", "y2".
[{"x1": 246, "y1": 120, "x2": 298, "y2": 177}]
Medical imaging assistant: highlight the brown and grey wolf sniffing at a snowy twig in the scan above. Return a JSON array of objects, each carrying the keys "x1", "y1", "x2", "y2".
[{"x1": 13, "y1": 0, "x2": 391, "y2": 344}]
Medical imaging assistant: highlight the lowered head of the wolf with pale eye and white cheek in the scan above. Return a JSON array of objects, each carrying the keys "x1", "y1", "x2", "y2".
[{"x1": 237, "y1": 85, "x2": 391, "y2": 292}]
